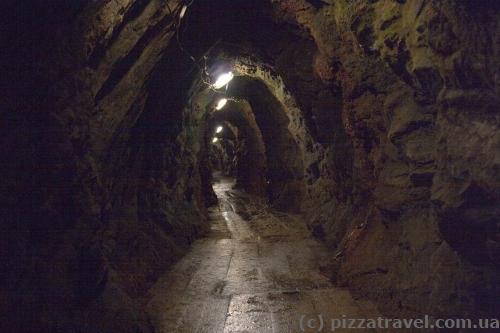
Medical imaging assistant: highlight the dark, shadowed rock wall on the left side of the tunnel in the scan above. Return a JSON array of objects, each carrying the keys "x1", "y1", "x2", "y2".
[{"x1": 0, "y1": 0, "x2": 204, "y2": 332}]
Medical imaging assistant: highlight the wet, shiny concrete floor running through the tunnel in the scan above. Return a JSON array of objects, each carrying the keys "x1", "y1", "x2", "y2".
[{"x1": 147, "y1": 175, "x2": 378, "y2": 333}]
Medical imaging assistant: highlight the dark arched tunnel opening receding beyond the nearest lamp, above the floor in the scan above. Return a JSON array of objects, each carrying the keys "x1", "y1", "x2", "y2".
[{"x1": 204, "y1": 76, "x2": 304, "y2": 211}]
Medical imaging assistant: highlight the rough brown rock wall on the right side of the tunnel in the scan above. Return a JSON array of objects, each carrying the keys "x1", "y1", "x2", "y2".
[{"x1": 273, "y1": 0, "x2": 500, "y2": 316}]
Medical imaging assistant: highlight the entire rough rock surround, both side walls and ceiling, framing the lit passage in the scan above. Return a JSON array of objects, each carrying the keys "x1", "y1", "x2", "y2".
[{"x1": 0, "y1": 0, "x2": 499, "y2": 332}]
